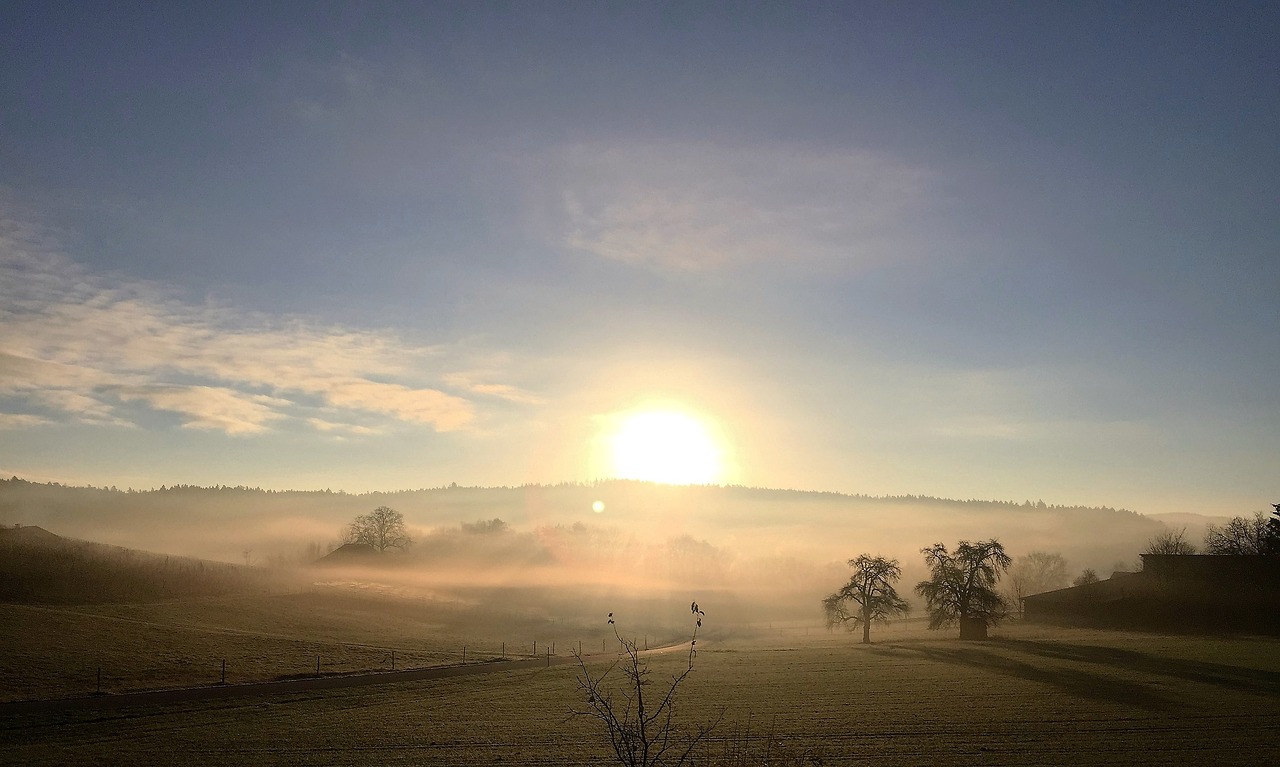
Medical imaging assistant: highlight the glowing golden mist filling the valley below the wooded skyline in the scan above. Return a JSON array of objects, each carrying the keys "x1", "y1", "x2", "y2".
[{"x1": 0, "y1": 479, "x2": 1192, "y2": 629}]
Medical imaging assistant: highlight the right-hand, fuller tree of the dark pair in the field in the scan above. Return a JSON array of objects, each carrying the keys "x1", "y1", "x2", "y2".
[{"x1": 915, "y1": 538, "x2": 1012, "y2": 639}]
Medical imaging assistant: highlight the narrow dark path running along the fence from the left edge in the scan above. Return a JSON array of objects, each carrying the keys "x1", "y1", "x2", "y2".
[{"x1": 0, "y1": 644, "x2": 689, "y2": 717}]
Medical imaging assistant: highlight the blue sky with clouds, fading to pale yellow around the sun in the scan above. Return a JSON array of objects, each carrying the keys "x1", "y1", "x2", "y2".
[{"x1": 0, "y1": 1, "x2": 1280, "y2": 515}]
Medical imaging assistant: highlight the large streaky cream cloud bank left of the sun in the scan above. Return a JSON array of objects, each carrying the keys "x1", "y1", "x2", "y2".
[{"x1": 0, "y1": 201, "x2": 538, "y2": 435}]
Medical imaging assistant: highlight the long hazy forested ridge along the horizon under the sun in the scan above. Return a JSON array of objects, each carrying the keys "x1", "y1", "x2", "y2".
[{"x1": 0, "y1": 478, "x2": 1162, "y2": 572}]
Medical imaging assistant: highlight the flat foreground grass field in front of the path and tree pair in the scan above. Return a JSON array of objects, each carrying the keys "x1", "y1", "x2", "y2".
[{"x1": 0, "y1": 626, "x2": 1280, "y2": 766}]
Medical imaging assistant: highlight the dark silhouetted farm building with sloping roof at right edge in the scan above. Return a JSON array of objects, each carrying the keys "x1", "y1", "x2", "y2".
[{"x1": 1023, "y1": 554, "x2": 1280, "y2": 633}]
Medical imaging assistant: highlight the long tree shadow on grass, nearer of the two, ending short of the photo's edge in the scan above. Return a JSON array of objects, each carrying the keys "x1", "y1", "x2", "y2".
[{"x1": 872, "y1": 645, "x2": 1179, "y2": 712}]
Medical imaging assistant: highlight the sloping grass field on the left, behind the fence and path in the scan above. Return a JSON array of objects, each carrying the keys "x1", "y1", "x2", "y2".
[{"x1": 0, "y1": 585, "x2": 640, "y2": 702}]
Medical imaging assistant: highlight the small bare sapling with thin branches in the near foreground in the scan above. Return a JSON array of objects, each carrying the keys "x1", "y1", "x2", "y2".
[{"x1": 570, "y1": 602, "x2": 719, "y2": 767}]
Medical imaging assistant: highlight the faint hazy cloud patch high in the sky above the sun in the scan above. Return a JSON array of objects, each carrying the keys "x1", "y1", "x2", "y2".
[{"x1": 548, "y1": 143, "x2": 931, "y2": 271}]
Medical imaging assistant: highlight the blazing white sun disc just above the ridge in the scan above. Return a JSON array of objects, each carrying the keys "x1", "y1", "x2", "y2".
[{"x1": 609, "y1": 410, "x2": 723, "y2": 485}]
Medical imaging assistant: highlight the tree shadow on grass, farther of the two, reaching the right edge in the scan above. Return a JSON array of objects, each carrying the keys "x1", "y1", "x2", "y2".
[{"x1": 993, "y1": 639, "x2": 1280, "y2": 698}]
